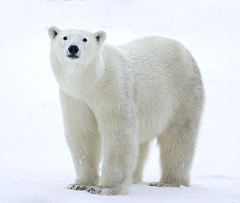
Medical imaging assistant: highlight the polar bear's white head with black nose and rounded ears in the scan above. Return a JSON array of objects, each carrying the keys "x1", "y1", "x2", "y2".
[{"x1": 48, "y1": 27, "x2": 106, "y2": 65}]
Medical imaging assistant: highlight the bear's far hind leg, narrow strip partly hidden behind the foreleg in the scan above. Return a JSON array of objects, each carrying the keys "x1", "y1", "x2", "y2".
[{"x1": 132, "y1": 141, "x2": 150, "y2": 183}]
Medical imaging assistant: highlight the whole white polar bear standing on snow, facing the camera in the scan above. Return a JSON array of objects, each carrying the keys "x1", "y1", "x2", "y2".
[{"x1": 48, "y1": 27, "x2": 204, "y2": 195}]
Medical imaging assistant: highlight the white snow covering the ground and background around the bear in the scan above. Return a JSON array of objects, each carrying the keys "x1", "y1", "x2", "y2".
[{"x1": 0, "y1": 0, "x2": 240, "y2": 203}]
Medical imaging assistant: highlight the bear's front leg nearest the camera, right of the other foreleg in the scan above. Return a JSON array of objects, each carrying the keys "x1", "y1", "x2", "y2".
[{"x1": 87, "y1": 106, "x2": 138, "y2": 195}]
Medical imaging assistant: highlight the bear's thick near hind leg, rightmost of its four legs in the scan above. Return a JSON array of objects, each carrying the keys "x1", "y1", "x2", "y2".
[{"x1": 150, "y1": 119, "x2": 198, "y2": 187}]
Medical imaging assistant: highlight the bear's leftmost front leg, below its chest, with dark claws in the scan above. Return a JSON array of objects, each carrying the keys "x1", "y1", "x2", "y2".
[{"x1": 60, "y1": 91, "x2": 101, "y2": 190}]
